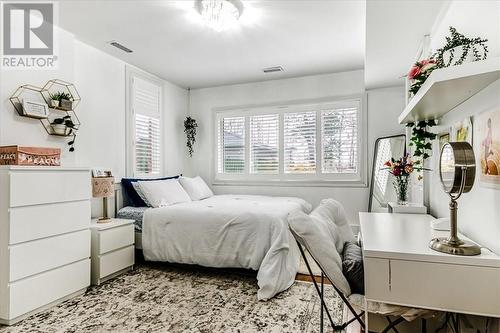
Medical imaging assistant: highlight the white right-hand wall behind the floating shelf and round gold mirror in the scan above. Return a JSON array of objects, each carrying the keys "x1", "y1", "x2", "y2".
[{"x1": 426, "y1": 1, "x2": 500, "y2": 254}]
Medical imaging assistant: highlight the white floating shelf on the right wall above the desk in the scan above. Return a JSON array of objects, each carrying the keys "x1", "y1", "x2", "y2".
[{"x1": 398, "y1": 57, "x2": 500, "y2": 124}]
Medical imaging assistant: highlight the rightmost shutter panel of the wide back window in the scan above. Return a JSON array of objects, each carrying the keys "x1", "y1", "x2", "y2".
[{"x1": 321, "y1": 106, "x2": 358, "y2": 173}]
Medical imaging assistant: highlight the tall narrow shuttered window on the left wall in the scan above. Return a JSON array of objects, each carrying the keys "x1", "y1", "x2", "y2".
[{"x1": 131, "y1": 77, "x2": 161, "y2": 176}]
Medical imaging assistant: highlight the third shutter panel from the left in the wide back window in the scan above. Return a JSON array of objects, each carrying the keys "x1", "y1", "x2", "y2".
[{"x1": 283, "y1": 111, "x2": 316, "y2": 174}]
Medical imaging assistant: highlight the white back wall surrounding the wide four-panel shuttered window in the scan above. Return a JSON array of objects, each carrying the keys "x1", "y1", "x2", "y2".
[{"x1": 186, "y1": 71, "x2": 404, "y2": 224}]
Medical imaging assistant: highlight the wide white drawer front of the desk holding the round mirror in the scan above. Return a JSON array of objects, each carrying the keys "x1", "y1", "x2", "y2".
[{"x1": 390, "y1": 260, "x2": 500, "y2": 317}]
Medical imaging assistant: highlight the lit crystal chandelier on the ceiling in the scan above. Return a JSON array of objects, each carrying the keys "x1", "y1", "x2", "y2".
[{"x1": 195, "y1": 0, "x2": 243, "y2": 32}]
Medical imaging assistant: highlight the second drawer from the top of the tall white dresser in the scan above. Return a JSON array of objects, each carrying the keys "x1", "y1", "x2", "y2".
[{"x1": 9, "y1": 200, "x2": 90, "y2": 244}]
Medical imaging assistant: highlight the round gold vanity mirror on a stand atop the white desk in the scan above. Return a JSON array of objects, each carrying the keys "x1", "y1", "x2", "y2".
[{"x1": 429, "y1": 142, "x2": 481, "y2": 256}]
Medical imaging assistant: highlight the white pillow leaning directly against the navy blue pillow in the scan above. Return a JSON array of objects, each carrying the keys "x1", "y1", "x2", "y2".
[{"x1": 138, "y1": 179, "x2": 191, "y2": 208}]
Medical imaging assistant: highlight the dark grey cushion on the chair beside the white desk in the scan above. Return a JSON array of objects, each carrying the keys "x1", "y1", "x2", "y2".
[{"x1": 342, "y1": 242, "x2": 365, "y2": 295}]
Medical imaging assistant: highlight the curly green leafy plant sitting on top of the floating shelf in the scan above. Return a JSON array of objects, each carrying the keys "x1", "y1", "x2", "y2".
[{"x1": 433, "y1": 27, "x2": 488, "y2": 68}]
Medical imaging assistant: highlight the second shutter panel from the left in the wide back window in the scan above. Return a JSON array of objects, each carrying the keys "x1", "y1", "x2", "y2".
[{"x1": 250, "y1": 114, "x2": 279, "y2": 174}]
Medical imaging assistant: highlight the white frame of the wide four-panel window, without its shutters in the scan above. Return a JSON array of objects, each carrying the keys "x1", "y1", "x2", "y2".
[{"x1": 212, "y1": 93, "x2": 368, "y2": 187}]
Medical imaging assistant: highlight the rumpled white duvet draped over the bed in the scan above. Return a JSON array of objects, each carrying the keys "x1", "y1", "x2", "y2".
[{"x1": 142, "y1": 195, "x2": 311, "y2": 300}]
